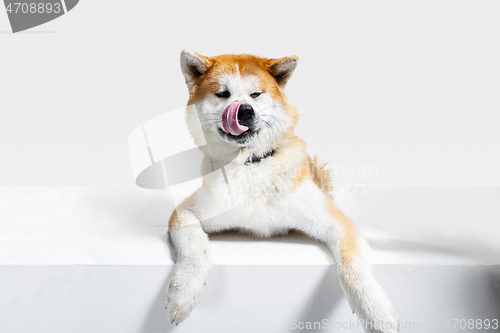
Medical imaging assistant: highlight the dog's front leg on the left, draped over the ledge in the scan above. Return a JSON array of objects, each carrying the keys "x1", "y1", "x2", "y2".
[{"x1": 165, "y1": 199, "x2": 211, "y2": 325}]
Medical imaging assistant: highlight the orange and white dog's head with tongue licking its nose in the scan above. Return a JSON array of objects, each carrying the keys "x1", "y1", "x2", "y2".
[{"x1": 181, "y1": 50, "x2": 298, "y2": 148}]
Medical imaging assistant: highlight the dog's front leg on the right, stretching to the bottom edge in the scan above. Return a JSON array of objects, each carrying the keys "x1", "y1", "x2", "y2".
[{"x1": 304, "y1": 195, "x2": 398, "y2": 333}]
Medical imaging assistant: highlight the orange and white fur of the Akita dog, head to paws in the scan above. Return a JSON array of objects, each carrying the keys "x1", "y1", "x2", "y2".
[{"x1": 165, "y1": 50, "x2": 398, "y2": 332}]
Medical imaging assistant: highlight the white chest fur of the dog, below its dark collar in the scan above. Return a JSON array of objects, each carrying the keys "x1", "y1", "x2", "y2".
[{"x1": 196, "y1": 153, "x2": 322, "y2": 237}]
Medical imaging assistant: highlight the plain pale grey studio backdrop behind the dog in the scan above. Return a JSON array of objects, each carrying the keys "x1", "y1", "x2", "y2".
[{"x1": 0, "y1": 0, "x2": 500, "y2": 186}]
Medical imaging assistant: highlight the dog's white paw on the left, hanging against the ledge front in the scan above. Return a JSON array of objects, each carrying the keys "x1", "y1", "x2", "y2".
[{"x1": 165, "y1": 280, "x2": 196, "y2": 325}]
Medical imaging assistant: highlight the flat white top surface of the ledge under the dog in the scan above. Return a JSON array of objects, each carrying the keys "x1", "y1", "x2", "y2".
[{"x1": 0, "y1": 187, "x2": 500, "y2": 265}]
